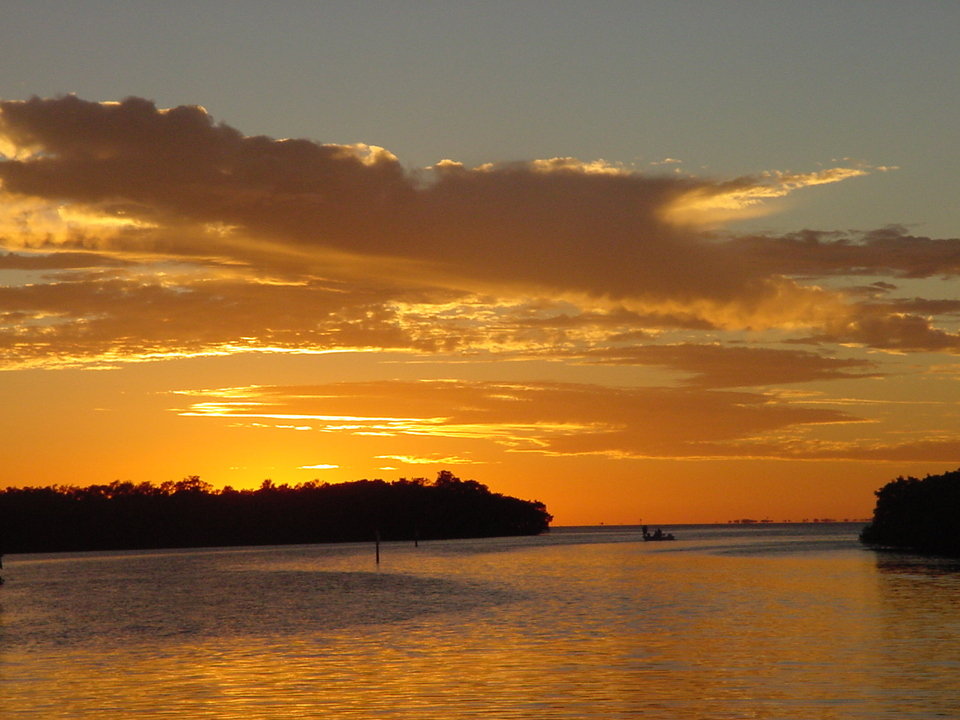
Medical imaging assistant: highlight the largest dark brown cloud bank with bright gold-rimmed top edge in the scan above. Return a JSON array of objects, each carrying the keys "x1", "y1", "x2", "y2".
[{"x1": 0, "y1": 96, "x2": 865, "y2": 312}]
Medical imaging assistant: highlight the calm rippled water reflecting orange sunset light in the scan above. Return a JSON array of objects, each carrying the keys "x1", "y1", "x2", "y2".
[{"x1": 0, "y1": 525, "x2": 960, "y2": 720}]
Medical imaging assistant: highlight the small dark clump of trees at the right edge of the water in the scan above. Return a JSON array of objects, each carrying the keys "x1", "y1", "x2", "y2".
[{"x1": 860, "y1": 469, "x2": 960, "y2": 557}]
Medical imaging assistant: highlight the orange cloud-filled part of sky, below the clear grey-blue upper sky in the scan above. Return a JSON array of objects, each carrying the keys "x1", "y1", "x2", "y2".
[{"x1": 0, "y1": 96, "x2": 960, "y2": 524}]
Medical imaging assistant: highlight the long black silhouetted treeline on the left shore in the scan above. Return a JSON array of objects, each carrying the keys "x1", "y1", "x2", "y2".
[{"x1": 0, "y1": 470, "x2": 552, "y2": 552}]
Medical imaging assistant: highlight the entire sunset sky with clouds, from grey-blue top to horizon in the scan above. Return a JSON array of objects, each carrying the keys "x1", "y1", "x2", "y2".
[{"x1": 0, "y1": 0, "x2": 960, "y2": 525}]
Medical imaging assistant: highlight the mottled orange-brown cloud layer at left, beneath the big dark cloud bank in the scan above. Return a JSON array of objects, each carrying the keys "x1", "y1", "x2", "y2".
[{"x1": 0, "y1": 276, "x2": 431, "y2": 368}]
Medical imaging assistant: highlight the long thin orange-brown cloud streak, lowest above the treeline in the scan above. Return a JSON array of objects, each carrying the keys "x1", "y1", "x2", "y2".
[{"x1": 176, "y1": 380, "x2": 960, "y2": 465}]
